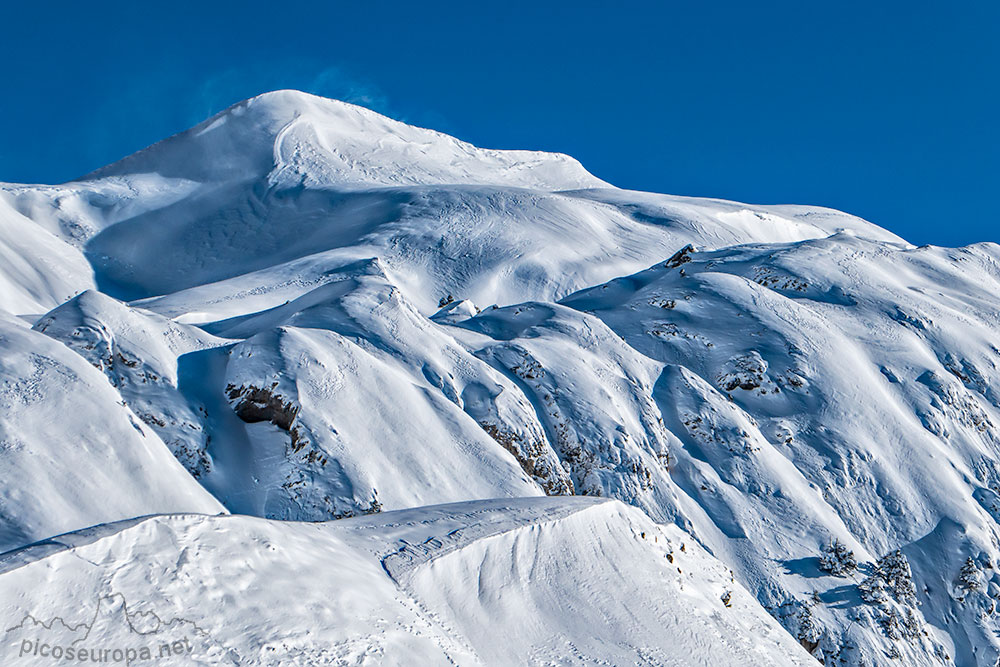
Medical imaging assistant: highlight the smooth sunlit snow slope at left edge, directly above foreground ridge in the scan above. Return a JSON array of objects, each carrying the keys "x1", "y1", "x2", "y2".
[{"x1": 0, "y1": 315, "x2": 224, "y2": 550}]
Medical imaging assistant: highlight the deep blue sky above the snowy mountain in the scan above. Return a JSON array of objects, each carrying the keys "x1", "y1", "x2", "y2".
[{"x1": 0, "y1": 0, "x2": 1000, "y2": 245}]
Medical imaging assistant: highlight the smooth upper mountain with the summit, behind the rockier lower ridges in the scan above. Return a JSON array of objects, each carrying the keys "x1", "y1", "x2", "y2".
[{"x1": 2, "y1": 91, "x2": 899, "y2": 310}]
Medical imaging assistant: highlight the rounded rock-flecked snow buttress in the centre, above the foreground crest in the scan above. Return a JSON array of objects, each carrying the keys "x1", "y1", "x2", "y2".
[{"x1": 453, "y1": 303, "x2": 678, "y2": 519}]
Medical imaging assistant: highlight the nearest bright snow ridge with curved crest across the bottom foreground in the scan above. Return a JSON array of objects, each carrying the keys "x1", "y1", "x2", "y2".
[{"x1": 0, "y1": 498, "x2": 814, "y2": 667}]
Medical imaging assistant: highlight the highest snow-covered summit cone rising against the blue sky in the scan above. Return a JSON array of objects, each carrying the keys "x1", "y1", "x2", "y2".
[{"x1": 85, "y1": 90, "x2": 610, "y2": 191}]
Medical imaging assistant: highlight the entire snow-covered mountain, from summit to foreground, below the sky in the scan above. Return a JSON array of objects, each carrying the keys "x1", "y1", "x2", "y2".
[{"x1": 0, "y1": 91, "x2": 1000, "y2": 667}]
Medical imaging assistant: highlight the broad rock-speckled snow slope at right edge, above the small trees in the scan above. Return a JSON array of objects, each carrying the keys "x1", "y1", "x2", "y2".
[{"x1": 564, "y1": 234, "x2": 1000, "y2": 664}]
